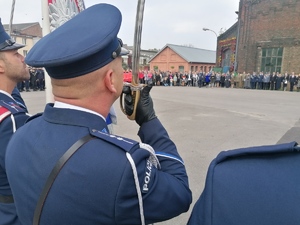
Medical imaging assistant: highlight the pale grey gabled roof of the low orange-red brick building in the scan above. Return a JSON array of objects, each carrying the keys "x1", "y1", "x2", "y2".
[{"x1": 150, "y1": 44, "x2": 216, "y2": 64}]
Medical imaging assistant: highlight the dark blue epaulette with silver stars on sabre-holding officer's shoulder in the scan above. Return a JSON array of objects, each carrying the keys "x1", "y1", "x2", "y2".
[{"x1": 90, "y1": 129, "x2": 139, "y2": 152}]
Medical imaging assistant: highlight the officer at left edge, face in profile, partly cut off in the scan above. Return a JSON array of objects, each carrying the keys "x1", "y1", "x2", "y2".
[{"x1": 0, "y1": 19, "x2": 29, "y2": 225}]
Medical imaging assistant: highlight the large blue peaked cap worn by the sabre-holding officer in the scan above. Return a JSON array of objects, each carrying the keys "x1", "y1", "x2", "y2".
[{"x1": 25, "y1": 4, "x2": 128, "y2": 79}]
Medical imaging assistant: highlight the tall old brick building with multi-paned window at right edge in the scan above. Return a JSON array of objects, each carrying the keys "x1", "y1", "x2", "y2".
[{"x1": 217, "y1": 0, "x2": 300, "y2": 73}]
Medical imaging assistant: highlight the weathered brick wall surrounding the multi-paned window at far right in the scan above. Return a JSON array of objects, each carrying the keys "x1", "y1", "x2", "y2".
[{"x1": 237, "y1": 0, "x2": 300, "y2": 73}]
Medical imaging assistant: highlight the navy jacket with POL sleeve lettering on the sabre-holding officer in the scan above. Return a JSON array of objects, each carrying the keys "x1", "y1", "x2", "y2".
[{"x1": 6, "y1": 104, "x2": 192, "y2": 225}]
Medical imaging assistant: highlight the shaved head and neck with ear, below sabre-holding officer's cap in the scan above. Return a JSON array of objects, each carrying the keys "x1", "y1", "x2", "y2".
[{"x1": 51, "y1": 57, "x2": 123, "y2": 115}]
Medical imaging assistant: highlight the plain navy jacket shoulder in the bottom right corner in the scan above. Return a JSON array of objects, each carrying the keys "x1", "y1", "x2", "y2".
[{"x1": 188, "y1": 142, "x2": 300, "y2": 225}]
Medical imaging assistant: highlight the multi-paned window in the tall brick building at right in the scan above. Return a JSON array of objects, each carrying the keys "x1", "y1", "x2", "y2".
[{"x1": 261, "y1": 48, "x2": 283, "y2": 73}]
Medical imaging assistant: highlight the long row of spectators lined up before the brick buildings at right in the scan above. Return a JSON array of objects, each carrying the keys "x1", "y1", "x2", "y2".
[{"x1": 124, "y1": 70, "x2": 300, "y2": 92}]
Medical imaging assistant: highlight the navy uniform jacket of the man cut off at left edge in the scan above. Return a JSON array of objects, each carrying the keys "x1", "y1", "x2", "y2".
[{"x1": 0, "y1": 91, "x2": 29, "y2": 225}]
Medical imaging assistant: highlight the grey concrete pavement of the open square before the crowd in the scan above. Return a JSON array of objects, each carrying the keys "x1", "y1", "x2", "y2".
[{"x1": 22, "y1": 86, "x2": 300, "y2": 225}]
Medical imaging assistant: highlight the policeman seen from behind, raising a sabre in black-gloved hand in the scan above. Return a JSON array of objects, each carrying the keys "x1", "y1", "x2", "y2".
[{"x1": 6, "y1": 4, "x2": 192, "y2": 225}]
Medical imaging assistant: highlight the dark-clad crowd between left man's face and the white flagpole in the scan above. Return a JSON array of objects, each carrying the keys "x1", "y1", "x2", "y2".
[{"x1": 18, "y1": 67, "x2": 45, "y2": 92}]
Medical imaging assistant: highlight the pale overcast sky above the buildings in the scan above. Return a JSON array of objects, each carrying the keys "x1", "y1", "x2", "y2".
[{"x1": 0, "y1": 0, "x2": 239, "y2": 50}]
